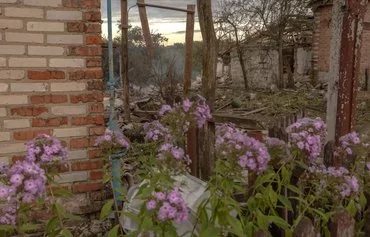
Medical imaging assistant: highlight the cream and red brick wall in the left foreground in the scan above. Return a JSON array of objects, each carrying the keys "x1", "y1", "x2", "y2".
[{"x1": 0, "y1": 0, "x2": 104, "y2": 213}]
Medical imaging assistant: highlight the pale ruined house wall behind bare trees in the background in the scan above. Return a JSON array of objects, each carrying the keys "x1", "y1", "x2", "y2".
[{"x1": 230, "y1": 48, "x2": 279, "y2": 88}]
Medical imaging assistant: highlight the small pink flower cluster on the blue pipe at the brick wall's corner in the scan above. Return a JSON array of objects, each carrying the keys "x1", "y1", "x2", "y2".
[{"x1": 95, "y1": 129, "x2": 130, "y2": 150}]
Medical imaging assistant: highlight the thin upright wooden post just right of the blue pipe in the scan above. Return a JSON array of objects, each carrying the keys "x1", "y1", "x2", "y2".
[{"x1": 121, "y1": 0, "x2": 131, "y2": 122}]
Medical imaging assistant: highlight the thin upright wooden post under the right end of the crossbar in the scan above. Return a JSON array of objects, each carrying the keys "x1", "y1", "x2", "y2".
[{"x1": 184, "y1": 5, "x2": 195, "y2": 97}]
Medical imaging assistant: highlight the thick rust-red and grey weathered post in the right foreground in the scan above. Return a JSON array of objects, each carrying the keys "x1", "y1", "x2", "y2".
[{"x1": 327, "y1": 0, "x2": 368, "y2": 142}]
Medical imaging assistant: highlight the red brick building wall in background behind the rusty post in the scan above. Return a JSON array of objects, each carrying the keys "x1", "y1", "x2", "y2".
[{"x1": 313, "y1": 5, "x2": 370, "y2": 81}]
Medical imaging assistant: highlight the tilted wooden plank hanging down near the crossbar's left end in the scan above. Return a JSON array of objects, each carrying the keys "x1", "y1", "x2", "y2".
[{"x1": 137, "y1": 0, "x2": 154, "y2": 66}]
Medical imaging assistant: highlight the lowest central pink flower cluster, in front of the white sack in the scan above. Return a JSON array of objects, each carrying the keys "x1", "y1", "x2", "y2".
[{"x1": 146, "y1": 188, "x2": 189, "y2": 224}]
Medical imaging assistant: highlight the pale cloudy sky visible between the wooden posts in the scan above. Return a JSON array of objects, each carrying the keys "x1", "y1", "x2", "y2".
[{"x1": 101, "y1": 0, "x2": 208, "y2": 45}]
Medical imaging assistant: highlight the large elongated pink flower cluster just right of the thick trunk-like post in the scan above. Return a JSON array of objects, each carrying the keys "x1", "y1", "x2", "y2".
[{"x1": 216, "y1": 124, "x2": 271, "y2": 173}]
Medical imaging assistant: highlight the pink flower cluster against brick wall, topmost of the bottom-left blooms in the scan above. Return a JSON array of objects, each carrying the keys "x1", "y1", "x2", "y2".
[{"x1": 25, "y1": 134, "x2": 67, "y2": 164}]
